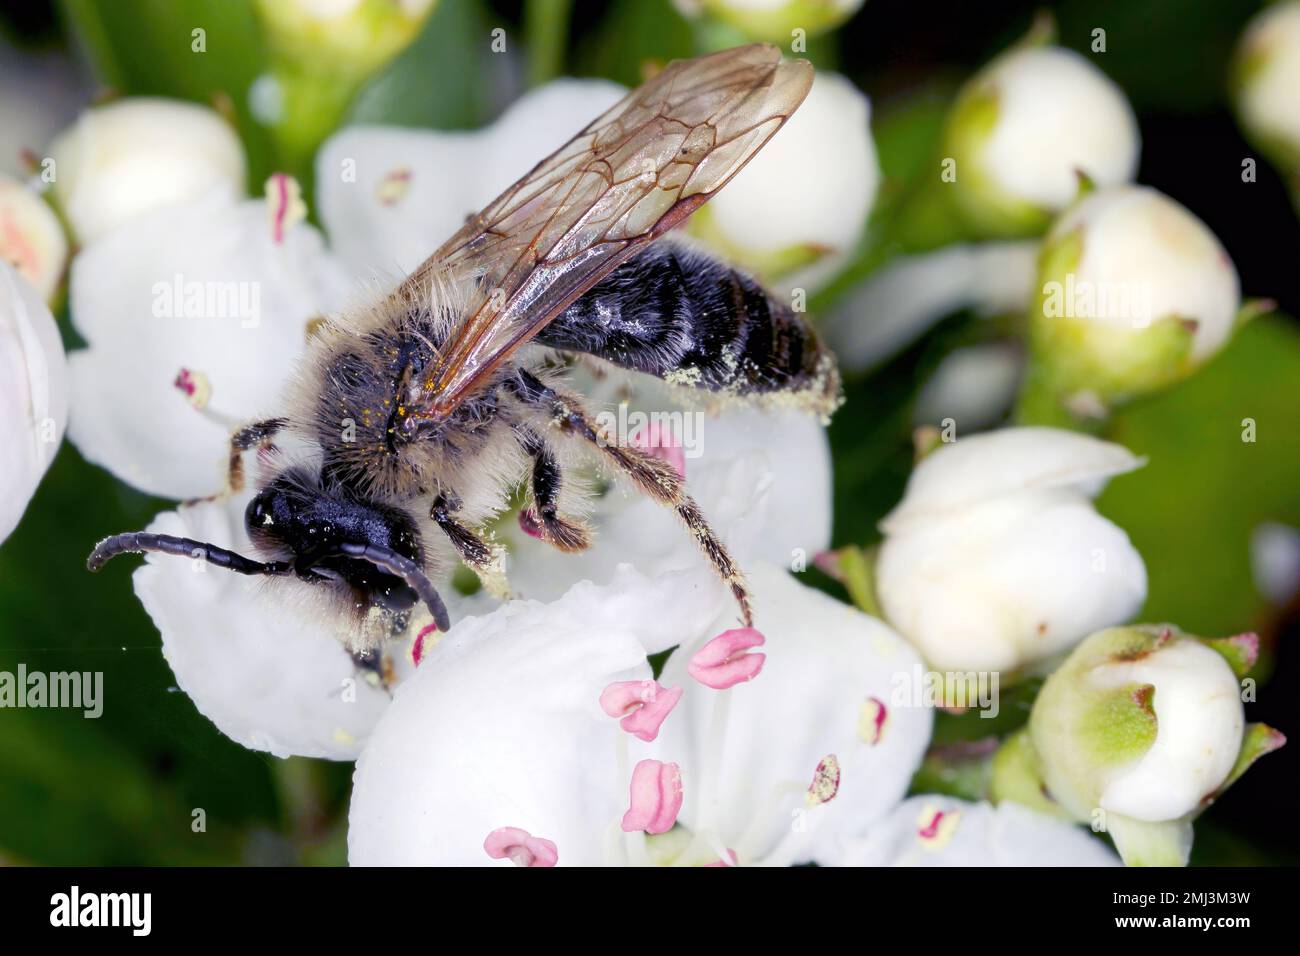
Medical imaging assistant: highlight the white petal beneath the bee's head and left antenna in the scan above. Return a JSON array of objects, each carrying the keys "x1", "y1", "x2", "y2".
[{"x1": 134, "y1": 498, "x2": 389, "y2": 760}]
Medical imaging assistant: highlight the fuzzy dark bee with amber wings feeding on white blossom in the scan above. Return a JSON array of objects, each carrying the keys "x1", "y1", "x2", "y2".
[{"x1": 87, "y1": 44, "x2": 840, "y2": 642}]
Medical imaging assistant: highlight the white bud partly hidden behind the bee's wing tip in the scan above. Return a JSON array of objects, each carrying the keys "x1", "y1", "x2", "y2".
[{"x1": 689, "y1": 70, "x2": 880, "y2": 287}]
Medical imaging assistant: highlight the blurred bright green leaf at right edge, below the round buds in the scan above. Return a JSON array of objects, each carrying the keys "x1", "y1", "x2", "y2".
[{"x1": 1099, "y1": 316, "x2": 1300, "y2": 633}]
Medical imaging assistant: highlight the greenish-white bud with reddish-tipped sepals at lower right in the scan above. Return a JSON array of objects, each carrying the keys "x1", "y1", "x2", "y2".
[{"x1": 1030, "y1": 624, "x2": 1283, "y2": 865}]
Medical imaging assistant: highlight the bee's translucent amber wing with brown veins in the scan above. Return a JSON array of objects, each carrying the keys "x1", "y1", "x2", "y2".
[{"x1": 399, "y1": 43, "x2": 813, "y2": 419}]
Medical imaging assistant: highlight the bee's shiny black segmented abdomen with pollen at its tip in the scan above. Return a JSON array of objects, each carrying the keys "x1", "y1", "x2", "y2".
[{"x1": 537, "y1": 239, "x2": 839, "y2": 412}]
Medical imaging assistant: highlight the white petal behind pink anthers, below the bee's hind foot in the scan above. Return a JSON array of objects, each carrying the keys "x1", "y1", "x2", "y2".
[{"x1": 651, "y1": 563, "x2": 932, "y2": 862}]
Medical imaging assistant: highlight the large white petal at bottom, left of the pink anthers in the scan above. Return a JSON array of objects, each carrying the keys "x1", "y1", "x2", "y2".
[{"x1": 348, "y1": 572, "x2": 660, "y2": 866}]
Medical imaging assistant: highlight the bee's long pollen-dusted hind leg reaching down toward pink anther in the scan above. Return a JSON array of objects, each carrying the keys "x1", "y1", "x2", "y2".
[{"x1": 506, "y1": 369, "x2": 754, "y2": 627}]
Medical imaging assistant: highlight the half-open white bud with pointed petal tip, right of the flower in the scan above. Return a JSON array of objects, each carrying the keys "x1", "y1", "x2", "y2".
[{"x1": 876, "y1": 428, "x2": 1147, "y2": 676}]
